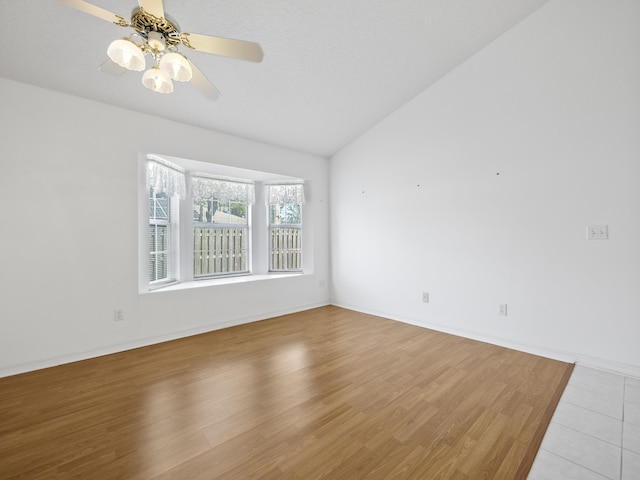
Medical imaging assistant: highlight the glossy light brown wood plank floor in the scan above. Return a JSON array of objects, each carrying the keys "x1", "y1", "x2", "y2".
[{"x1": 0, "y1": 306, "x2": 573, "y2": 480}]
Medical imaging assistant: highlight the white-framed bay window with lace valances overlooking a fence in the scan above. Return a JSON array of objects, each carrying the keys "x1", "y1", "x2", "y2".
[{"x1": 138, "y1": 154, "x2": 304, "y2": 292}]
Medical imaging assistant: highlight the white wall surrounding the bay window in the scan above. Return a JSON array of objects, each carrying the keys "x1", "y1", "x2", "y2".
[{"x1": 0, "y1": 79, "x2": 329, "y2": 376}]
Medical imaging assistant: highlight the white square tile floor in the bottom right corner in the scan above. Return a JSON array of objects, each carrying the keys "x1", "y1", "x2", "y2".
[{"x1": 528, "y1": 365, "x2": 640, "y2": 480}]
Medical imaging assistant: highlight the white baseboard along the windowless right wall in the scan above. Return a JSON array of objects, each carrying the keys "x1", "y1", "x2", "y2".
[{"x1": 332, "y1": 302, "x2": 640, "y2": 379}]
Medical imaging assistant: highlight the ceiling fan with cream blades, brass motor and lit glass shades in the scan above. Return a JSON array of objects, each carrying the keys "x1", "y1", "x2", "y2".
[{"x1": 59, "y1": 0, "x2": 264, "y2": 100}]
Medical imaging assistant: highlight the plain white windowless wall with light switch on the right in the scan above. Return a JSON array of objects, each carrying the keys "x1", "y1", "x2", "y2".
[{"x1": 330, "y1": 0, "x2": 640, "y2": 376}]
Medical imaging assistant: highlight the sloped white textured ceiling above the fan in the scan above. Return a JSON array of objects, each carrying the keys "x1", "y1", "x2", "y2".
[{"x1": 0, "y1": 0, "x2": 548, "y2": 157}]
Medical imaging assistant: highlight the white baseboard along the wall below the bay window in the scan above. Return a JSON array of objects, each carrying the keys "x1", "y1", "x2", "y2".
[{"x1": 0, "y1": 303, "x2": 329, "y2": 378}]
